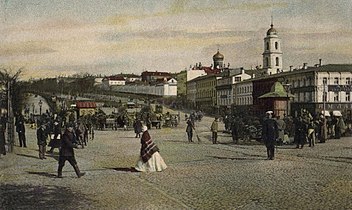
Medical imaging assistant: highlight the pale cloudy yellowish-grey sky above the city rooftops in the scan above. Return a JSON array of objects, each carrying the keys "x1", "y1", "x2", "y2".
[{"x1": 0, "y1": 0, "x2": 352, "y2": 79}]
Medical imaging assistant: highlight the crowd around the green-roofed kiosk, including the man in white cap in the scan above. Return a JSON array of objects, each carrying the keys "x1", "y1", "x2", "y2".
[{"x1": 221, "y1": 109, "x2": 350, "y2": 160}]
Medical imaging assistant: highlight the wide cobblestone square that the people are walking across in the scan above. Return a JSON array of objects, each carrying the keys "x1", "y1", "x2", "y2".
[{"x1": 0, "y1": 112, "x2": 352, "y2": 210}]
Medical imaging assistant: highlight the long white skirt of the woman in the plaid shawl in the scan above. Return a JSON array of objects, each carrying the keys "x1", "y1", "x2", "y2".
[{"x1": 134, "y1": 152, "x2": 167, "y2": 172}]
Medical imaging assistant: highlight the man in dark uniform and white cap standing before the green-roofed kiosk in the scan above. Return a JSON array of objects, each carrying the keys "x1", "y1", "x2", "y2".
[{"x1": 262, "y1": 111, "x2": 279, "y2": 160}]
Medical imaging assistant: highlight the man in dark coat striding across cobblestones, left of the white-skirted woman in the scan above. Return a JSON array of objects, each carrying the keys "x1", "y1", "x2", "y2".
[{"x1": 57, "y1": 123, "x2": 85, "y2": 178}]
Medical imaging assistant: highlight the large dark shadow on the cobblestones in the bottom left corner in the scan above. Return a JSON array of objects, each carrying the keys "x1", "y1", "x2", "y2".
[{"x1": 0, "y1": 184, "x2": 91, "y2": 210}]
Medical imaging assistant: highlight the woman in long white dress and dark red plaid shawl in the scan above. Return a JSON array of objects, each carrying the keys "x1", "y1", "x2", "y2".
[{"x1": 135, "y1": 126, "x2": 167, "y2": 172}]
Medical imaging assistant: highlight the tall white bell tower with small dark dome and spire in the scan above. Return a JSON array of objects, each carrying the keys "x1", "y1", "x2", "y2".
[{"x1": 263, "y1": 17, "x2": 282, "y2": 75}]
